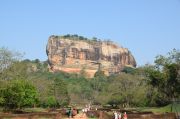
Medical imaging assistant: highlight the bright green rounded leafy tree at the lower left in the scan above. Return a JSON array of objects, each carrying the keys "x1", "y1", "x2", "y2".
[{"x1": 1, "y1": 80, "x2": 38, "y2": 109}]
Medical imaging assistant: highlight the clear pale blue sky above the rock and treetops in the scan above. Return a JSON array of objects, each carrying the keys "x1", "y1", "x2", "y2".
[{"x1": 0, "y1": 0, "x2": 180, "y2": 66}]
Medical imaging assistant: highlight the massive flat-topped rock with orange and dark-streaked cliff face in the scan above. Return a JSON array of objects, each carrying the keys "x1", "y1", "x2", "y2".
[{"x1": 46, "y1": 35, "x2": 136, "y2": 77}]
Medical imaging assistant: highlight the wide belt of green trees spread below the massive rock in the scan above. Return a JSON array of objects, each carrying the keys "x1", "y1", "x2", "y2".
[{"x1": 0, "y1": 48, "x2": 180, "y2": 109}]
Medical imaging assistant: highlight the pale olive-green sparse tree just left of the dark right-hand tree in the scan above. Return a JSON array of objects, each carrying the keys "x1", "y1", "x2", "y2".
[{"x1": 107, "y1": 73, "x2": 147, "y2": 107}]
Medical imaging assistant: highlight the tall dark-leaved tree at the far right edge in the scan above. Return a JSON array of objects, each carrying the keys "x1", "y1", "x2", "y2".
[{"x1": 148, "y1": 49, "x2": 180, "y2": 105}]
